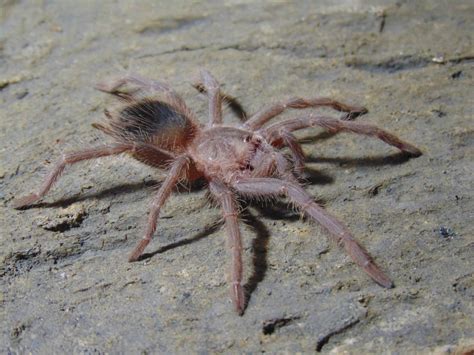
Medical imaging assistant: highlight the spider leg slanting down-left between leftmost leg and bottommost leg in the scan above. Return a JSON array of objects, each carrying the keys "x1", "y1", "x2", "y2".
[{"x1": 128, "y1": 155, "x2": 189, "y2": 262}]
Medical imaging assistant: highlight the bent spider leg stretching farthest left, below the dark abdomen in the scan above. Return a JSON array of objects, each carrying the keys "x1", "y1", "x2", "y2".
[{"x1": 13, "y1": 143, "x2": 141, "y2": 208}]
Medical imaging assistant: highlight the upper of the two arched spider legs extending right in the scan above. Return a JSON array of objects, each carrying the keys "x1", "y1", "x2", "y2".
[{"x1": 243, "y1": 97, "x2": 368, "y2": 130}]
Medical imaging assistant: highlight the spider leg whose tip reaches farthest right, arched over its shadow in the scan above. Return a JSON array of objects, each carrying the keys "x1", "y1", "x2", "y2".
[{"x1": 261, "y1": 115, "x2": 422, "y2": 156}]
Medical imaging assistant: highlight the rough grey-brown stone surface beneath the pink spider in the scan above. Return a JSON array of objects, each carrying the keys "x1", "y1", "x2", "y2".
[{"x1": 0, "y1": 0, "x2": 474, "y2": 354}]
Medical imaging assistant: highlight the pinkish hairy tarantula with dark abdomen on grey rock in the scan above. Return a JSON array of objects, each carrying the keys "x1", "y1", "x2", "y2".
[{"x1": 14, "y1": 70, "x2": 421, "y2": 315}]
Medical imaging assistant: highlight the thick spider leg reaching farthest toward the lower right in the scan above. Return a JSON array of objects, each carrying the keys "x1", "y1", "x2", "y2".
[{"x1": 233, "y1": 178, "x2": 393, "y2": 288}]
